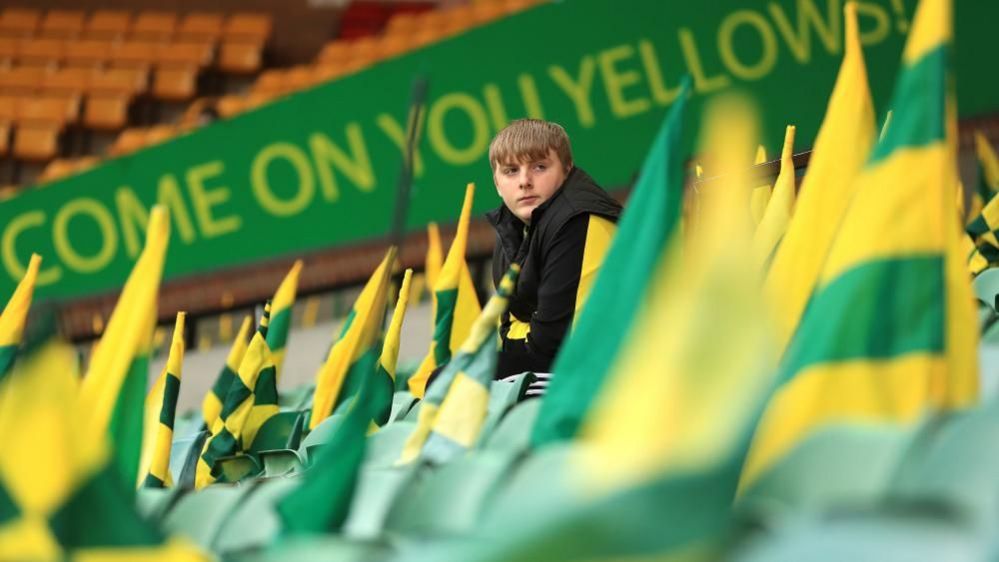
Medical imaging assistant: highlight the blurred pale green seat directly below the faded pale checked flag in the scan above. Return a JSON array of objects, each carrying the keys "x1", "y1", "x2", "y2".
[{"x1": 385, "y1": 450, "x2": 519, "y2": 538}]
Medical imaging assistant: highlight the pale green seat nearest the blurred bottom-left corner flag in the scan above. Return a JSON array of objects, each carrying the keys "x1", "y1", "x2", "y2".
[{"x1": 163, "y1": 484, "x2": 254, "y2": 550}]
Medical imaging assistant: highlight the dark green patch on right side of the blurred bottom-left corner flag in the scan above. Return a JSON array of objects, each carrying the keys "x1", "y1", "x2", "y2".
[{"x1": 49, "y1": 467, "x2": 163, "y2": 550}]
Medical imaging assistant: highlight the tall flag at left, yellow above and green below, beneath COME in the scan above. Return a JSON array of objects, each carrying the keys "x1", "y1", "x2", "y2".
[{"x1": 80, "y1": 205, "x2": 170, "y2": 489}]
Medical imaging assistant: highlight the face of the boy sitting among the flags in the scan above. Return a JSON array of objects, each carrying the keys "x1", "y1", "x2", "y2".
[{"x1": 493, "y1": 150, "x2": 569, "y2": 224}]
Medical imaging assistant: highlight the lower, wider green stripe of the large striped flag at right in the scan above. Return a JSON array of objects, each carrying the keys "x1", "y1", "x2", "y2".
[{"x1": 779, "y1": 255, "x2": 946, "y2": 382}]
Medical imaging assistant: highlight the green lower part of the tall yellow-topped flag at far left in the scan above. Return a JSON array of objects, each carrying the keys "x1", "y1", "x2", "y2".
[{"x1": 108, "y1": 355, "x2": 149, "y2": 491}]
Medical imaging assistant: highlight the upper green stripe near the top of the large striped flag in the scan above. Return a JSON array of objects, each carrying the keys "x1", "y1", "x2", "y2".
[{"x1": 868, "y1": 45, "x2": 950, "y2": 165}]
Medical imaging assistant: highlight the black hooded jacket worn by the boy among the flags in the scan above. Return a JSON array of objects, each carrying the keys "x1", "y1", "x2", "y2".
[{"x1": 486, "y1": 168, "x2": 621, "y2": 378}]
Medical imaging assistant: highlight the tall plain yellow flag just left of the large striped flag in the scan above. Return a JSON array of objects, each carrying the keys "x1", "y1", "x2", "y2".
[{"x1": 763, "y1": 2, "x2": 876, "y2": 353}]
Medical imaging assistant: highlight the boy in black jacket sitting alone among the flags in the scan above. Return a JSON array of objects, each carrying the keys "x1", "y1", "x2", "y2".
[{"x1": 487, "y1": 119, "x2": 621, "y2": 378}]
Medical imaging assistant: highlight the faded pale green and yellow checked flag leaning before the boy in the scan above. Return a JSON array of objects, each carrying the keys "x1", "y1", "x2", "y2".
[{"x1": 422, "y1": 264, "x2": 520, "y2": 463}]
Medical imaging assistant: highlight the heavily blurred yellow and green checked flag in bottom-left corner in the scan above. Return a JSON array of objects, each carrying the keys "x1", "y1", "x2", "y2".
[{"x1": 0, "y1": 339, "x2": 207, "y2": 562}]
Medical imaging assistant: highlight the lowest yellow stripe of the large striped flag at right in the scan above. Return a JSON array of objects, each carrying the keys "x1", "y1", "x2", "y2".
[{"x1": 740, "y1": 354, "x2": 947, "y2": 489}]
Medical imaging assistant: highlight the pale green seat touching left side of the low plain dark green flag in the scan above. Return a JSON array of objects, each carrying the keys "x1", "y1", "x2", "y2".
[{"x1": 214, "y1": 478, "x2": 299, "y2": 553}]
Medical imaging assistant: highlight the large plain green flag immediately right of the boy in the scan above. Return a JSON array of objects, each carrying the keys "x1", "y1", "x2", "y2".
[{"x1": 531, "y1": 82, "x2": 690, "y2": 446}]
